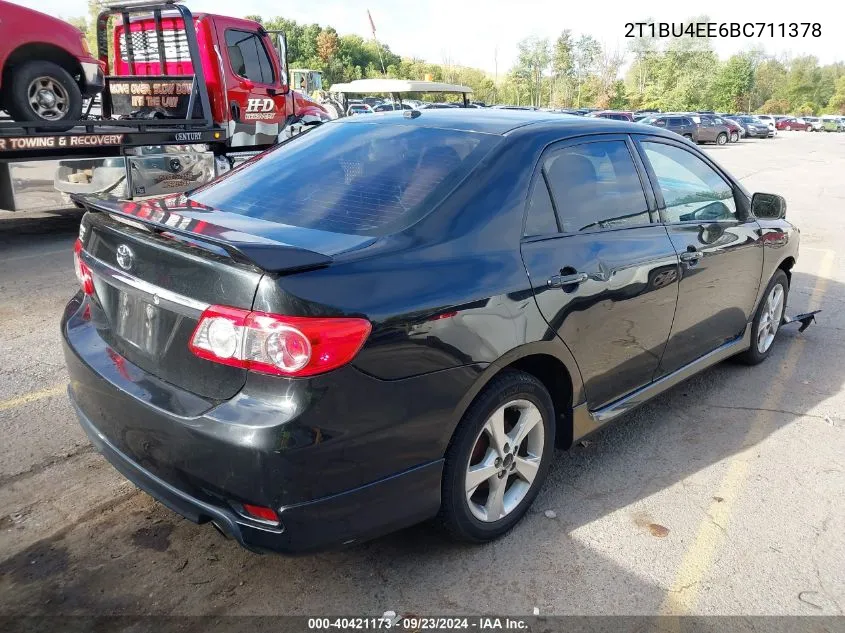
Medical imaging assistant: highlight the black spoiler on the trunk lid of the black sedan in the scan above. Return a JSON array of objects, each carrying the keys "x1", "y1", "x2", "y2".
[{"x1": 70, "y1": 194, "x2": 333, "y2": 273}]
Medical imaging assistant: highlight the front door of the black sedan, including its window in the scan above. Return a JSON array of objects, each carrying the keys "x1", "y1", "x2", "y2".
[{"x1": 639, "y1": 137, "x2": 763, "y2": 376}]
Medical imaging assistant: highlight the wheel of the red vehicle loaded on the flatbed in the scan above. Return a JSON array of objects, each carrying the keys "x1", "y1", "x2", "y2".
[{"x1": 7, "y1": 61, "x2": 82, "y2": 132}]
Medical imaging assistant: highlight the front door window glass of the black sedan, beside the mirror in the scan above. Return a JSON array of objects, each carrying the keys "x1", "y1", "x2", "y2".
[{"x1": 642, "y1": 142, "x2": 737, "y2": 222}]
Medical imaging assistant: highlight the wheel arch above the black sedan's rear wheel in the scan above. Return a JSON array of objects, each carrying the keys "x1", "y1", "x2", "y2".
[{"x1": 447, "y1": 341, "x2": 584, "y2": 448}]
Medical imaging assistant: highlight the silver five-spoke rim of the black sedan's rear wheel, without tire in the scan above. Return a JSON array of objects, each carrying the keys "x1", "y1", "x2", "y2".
[{"x1": 464, "y1": 400, "x2": 546, "y2": 523}]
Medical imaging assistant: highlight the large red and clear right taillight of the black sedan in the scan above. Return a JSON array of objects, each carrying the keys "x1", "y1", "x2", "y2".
[{"x1": 188, "y1": 306, "x2": 371, "y2": 376}]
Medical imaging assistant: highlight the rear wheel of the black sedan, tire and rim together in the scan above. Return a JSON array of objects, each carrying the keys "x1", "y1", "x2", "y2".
[{"x1": 438, "y1": 371, "x2": 555, "y2": 543}]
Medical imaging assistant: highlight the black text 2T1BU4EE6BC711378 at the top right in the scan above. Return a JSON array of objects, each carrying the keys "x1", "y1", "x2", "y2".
[{"x1": 625, "y1": 22, "x2": 822, "y2": 38}]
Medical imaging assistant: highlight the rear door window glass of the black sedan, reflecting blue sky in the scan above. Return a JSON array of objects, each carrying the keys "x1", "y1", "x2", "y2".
[{"x1": 543, "y1": 141, "x2": 649, "y2": 233}]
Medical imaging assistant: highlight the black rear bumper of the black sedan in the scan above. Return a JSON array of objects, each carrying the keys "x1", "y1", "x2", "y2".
[{"x1": 62, "y1": 294, "x2": 477, "y2": 553}]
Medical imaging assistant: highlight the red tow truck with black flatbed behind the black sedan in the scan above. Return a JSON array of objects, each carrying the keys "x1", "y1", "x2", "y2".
[{"x1": 0, "y1": 0, "x2": 331, "y2": 211}]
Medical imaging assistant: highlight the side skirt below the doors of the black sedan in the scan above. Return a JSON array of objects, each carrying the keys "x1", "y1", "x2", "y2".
[{"x1": 572, "y1": 323, "x2": 751, "y2": 442}]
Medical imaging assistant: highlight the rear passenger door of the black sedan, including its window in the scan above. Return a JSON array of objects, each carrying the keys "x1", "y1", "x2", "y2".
[{"x1": 521, "y1": 135, "x2": 678, "y2": 408}]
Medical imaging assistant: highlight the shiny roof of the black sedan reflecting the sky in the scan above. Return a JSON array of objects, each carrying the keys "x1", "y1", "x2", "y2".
[{"x1": 336, "y1": 108, "x2": 675, "y2": 138}]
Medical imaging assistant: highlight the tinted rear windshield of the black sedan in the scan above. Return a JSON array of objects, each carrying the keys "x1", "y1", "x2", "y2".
[{"x1": 189, "y1": 115, "x2": 500, "y2": 236}]
